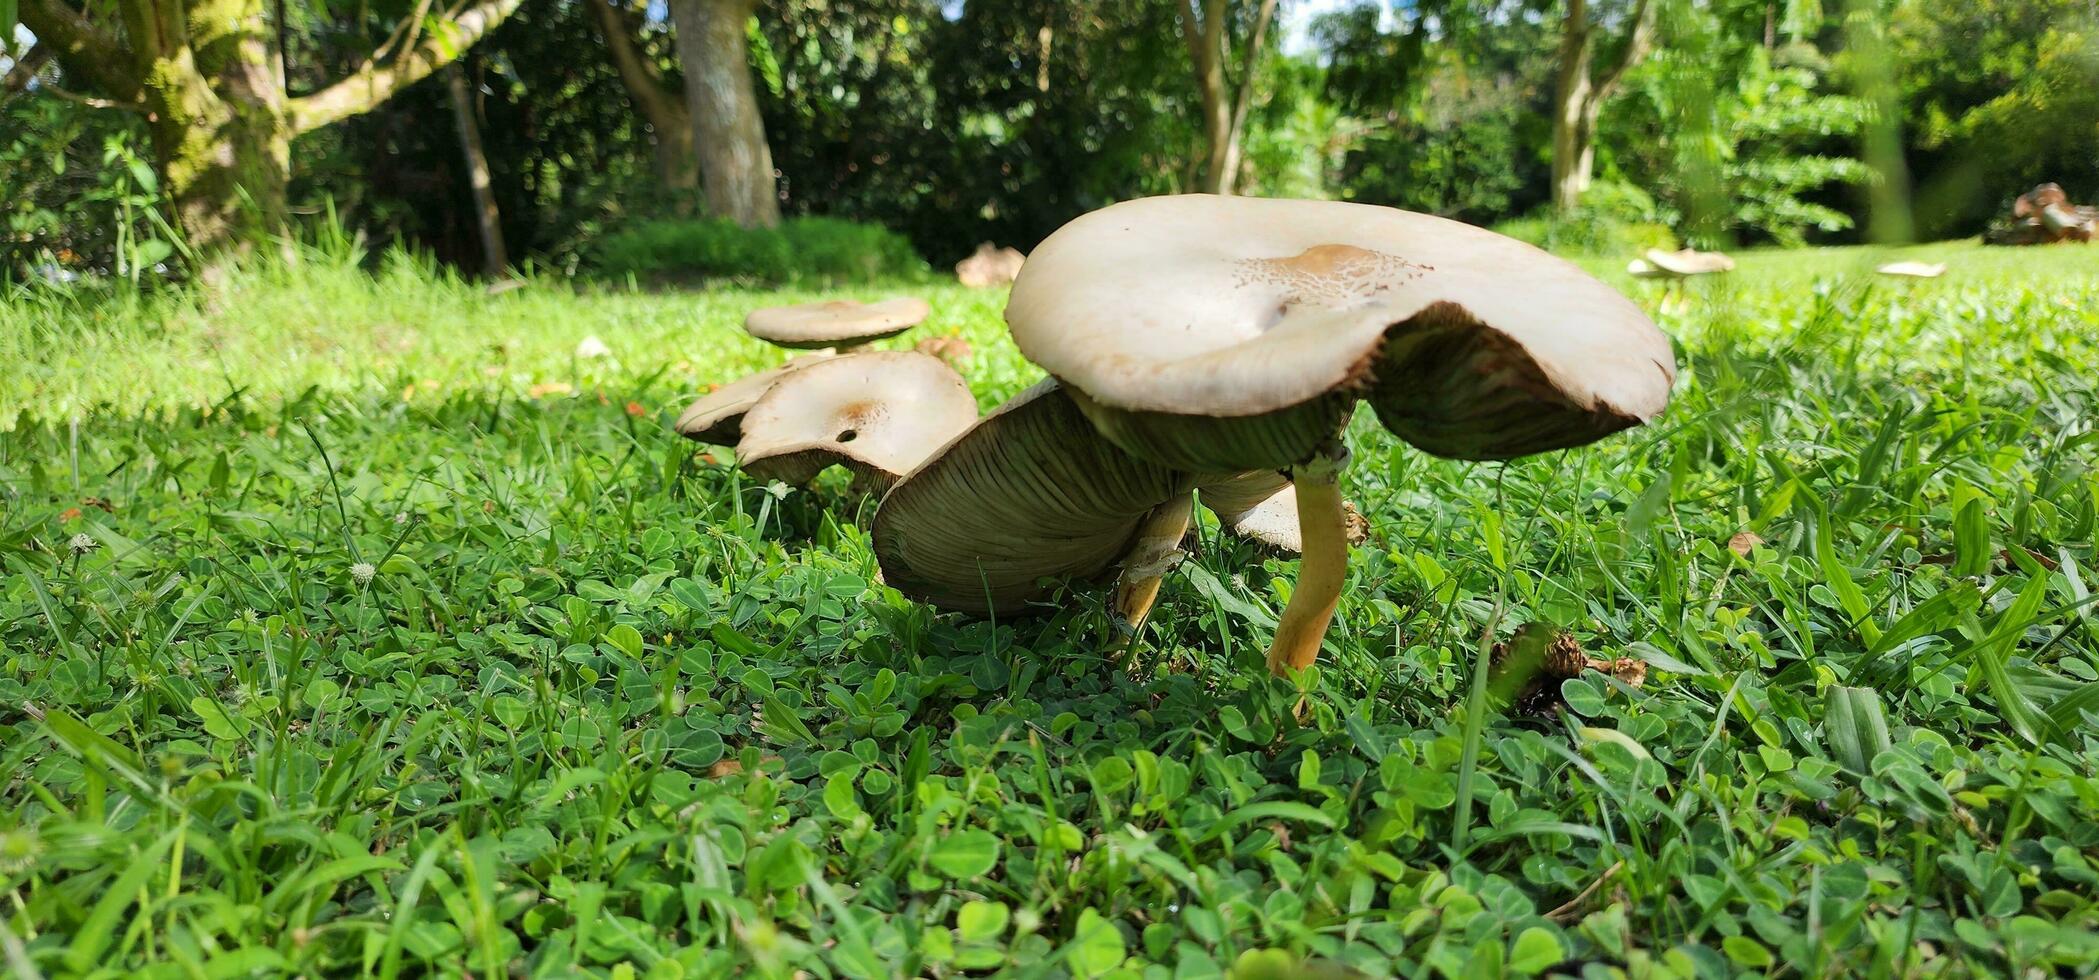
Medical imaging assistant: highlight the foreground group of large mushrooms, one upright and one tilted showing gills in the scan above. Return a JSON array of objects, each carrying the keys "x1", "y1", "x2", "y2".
[{"x1": 873, "y1": 195, "x2": 1675, "y2": 674}]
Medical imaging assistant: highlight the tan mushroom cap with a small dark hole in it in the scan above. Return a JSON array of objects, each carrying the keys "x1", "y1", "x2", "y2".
[{"x1": 737, "y1": 350, "x2": 976, "y2": 487}]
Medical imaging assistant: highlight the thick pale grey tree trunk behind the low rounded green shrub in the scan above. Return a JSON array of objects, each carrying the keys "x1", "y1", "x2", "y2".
[{"x1": 670, "y1": 0, "x2": 781, "y2": 229}]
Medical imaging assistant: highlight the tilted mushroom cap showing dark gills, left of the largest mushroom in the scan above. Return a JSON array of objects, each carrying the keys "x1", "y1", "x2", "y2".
[{"x1": 873, "y1": 382, "x2": 1192, "y2": 615}]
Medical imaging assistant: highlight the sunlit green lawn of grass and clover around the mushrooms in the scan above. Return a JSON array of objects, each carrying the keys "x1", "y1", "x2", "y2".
[{"x1": 0, "y1": 246, "x2": 2099, "y2": 978}]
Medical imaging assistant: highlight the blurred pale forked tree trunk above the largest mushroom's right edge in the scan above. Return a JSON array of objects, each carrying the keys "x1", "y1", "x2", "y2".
[{"x1": 1553, "y1": 0, "x2": 1658, "y2": 210}]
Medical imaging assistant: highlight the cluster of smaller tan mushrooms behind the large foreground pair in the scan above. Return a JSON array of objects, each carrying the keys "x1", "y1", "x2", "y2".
[{"x1": 676, "y1": 298, "x2": 976, "y2": 491}]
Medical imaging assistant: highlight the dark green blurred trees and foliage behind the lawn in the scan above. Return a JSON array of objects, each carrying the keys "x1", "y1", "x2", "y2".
[{"x1": 0, "y1": 0, "x2": 2099, "y2": 281}]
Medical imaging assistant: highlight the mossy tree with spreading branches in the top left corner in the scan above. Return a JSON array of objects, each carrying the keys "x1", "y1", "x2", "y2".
[{"x1": 19, "y1": 0, "x2": 521, "y2": 254}]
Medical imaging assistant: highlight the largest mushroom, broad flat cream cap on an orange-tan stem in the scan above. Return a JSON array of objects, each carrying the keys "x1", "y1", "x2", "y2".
[{"x1": 999, "y1": 195, "x2": 1675, "y2": 674}]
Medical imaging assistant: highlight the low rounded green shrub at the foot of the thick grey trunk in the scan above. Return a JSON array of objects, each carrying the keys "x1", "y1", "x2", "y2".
[{"x1": 594, "y1": 218, "x2": 926, "y2": 283}]
